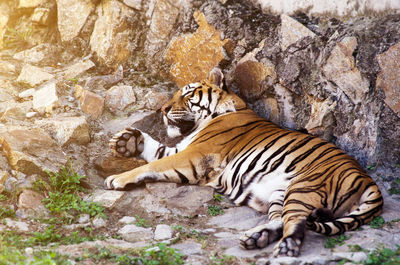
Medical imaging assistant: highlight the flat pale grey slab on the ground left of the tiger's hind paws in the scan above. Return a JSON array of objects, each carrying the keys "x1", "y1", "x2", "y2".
[{"x1": 207, "y1": 206, "x2": 268, "y2": 231}]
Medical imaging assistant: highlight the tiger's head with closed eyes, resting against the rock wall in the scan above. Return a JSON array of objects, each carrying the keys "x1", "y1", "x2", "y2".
[{"x1": 161, "y1": 68, "x2": 247, "y2": 137}]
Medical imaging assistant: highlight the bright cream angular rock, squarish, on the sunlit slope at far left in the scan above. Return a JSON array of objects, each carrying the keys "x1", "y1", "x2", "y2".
[{"x1": 33, "y1": 82, "x2": 59, "y2": 113}]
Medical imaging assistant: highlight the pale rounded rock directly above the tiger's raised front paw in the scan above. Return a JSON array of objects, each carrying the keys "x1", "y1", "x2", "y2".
[{"x1": 105, "y1": 86, "x2": 136, "y2": 112}]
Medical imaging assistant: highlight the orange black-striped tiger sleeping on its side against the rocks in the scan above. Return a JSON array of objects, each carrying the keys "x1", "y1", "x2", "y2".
[{"x1": 104, "y1": 68, "x2": 383, "y2": 256}]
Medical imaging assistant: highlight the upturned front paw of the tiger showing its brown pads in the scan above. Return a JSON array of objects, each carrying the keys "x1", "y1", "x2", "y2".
[{"x1": 109, "y1": 128, "x2": 144, "y2": 157}]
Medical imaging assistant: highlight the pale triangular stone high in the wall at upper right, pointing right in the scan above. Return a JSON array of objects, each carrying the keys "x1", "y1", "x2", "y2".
[{"x1": 281, "y1": 14, "x2": 316, "y2": 51}]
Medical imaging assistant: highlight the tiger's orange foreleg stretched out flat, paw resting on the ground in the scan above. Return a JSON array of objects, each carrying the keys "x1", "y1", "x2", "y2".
[{"x1": 104, "y1": 149, "x2": 216, "y2": 189}]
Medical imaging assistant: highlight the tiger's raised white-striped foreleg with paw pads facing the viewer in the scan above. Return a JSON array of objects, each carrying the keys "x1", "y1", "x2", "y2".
[{"x1": 109, "y1": 128, "x2": 179, "y2": 162}]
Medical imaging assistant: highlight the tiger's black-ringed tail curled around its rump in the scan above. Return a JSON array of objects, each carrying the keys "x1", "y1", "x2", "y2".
[{"x1": 306, "y1": 183, "x2": 383, "y2": 236}]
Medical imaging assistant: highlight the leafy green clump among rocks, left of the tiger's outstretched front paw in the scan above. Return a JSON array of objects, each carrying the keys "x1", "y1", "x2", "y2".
[{"x1": 34, "y1": 163, "x2": 105, "y2": 221}]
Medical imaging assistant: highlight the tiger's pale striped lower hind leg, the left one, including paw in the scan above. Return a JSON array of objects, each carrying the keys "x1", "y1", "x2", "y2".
[{"x1": 240, "y1": 189, "x2": 285, "y2": 249}]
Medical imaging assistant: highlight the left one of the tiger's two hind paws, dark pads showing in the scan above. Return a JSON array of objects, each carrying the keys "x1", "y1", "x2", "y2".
[{"x1": 240, "y1": 222, "x2": 282, "y2": 249}]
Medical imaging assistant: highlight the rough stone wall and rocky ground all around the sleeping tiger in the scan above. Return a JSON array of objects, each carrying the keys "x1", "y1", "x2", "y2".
[{"x1": 0, "y1": 0, "x2": 400, "y2": 264}]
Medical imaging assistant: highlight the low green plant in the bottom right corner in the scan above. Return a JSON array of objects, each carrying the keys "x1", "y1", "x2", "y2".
[{"x1": 363, "y1": 244, "x2": 400, "y2": 265}]
